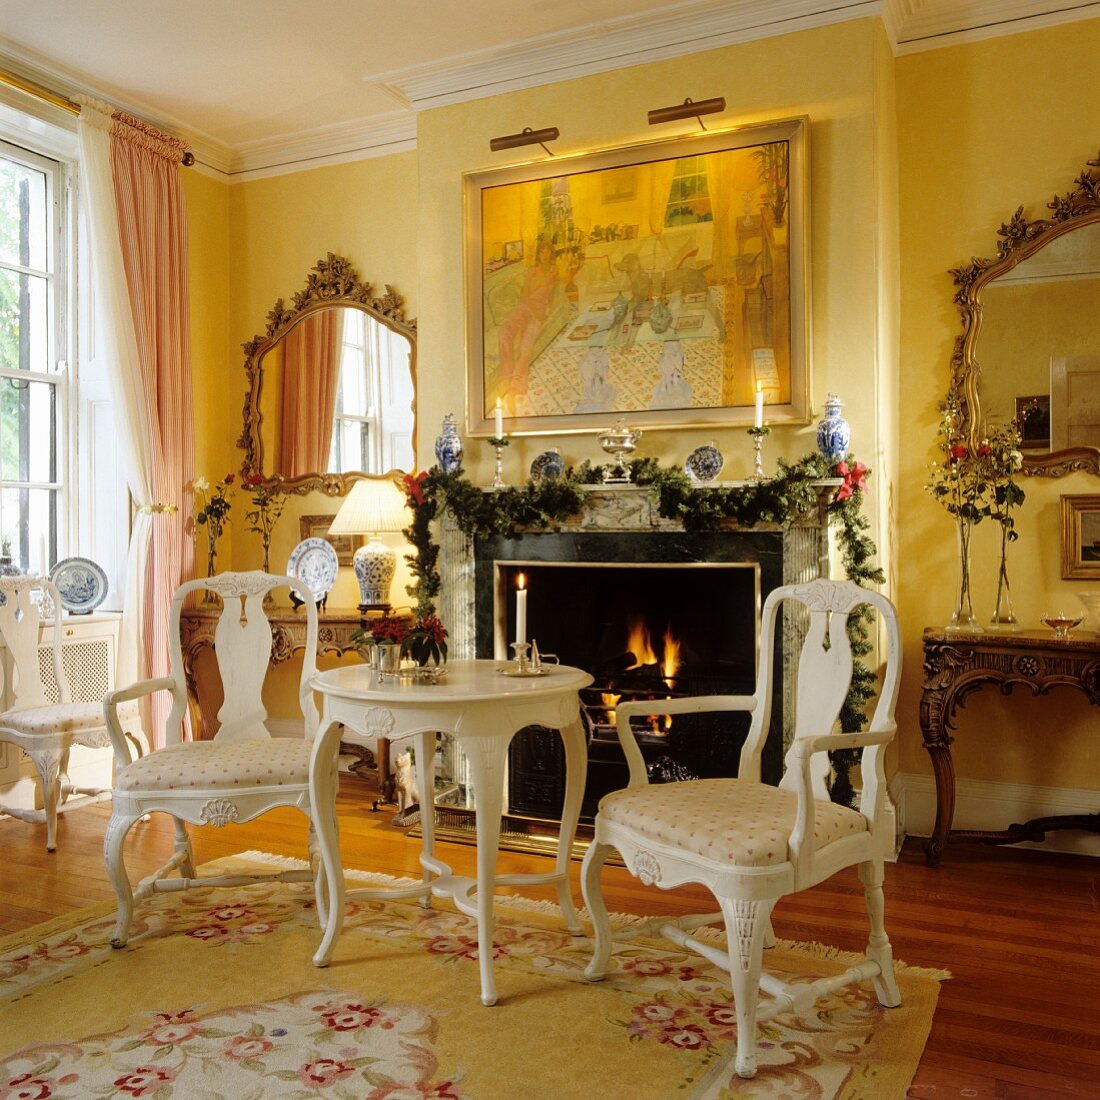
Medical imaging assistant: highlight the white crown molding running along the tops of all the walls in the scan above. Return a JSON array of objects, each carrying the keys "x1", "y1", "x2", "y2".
[{"x1": 0, "y1": 0, "x2": 1100, "y2": 176}]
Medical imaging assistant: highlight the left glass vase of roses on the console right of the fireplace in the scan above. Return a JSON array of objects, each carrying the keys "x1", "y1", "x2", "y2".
[{"x1": 925, "y1": 405, "x2": 991, "y2": 633}]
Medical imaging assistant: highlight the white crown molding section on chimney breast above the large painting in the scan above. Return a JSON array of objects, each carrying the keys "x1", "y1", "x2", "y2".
[{"x1": 364, "y1": 0, "x2": 881, "y2": 110}]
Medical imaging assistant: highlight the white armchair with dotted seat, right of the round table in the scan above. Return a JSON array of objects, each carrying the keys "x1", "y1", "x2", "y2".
[{"x1": 581, "y1": 581, "x2": 901, "y2": 1077}]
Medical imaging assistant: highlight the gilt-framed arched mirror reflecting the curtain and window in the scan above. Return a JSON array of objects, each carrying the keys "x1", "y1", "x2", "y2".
[{"x1": 238, "y1": 252, "x2": 416, "y2": 496}]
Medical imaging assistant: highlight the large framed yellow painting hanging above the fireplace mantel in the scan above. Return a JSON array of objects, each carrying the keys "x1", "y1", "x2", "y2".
[{"x1": 464, "y1": 119, "x2": 810, "y2": 436}]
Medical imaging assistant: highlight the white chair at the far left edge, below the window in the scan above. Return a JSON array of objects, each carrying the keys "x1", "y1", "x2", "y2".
[{"x1": 0, "y1": 576, "x2": 142, "y2": 851}]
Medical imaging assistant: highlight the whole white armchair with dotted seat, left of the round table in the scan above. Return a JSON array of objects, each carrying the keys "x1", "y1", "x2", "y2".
[{"x1": 103, "y1": 571, "x2": 327, "y2": 947}]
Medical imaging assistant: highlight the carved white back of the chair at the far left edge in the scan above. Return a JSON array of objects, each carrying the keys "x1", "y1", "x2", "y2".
[{"x1": 0, "y1": 576, "x2": 73, "y2": 710}]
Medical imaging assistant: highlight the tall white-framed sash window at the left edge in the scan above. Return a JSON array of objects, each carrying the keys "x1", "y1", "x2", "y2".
[{"x1": 0, "y1": 142, "x2": 68, "y2": 572}]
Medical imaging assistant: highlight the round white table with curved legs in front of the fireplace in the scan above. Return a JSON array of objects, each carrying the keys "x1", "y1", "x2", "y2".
[{"x1": 309, "y1": 660, "x2": 592, "y2": 1004}]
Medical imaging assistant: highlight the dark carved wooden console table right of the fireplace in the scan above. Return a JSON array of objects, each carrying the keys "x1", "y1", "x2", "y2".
[{"x1": 921, "y1": 630, "x2": 1100, "y2": 867}]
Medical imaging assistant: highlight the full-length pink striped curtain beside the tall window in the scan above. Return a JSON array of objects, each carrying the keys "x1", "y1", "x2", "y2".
[{"x1": 110, "y1": 111, "x2": 195, "y2": 737}]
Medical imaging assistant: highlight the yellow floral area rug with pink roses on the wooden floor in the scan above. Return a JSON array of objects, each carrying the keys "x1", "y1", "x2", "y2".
[{"x1": 0, "y1": 853, "x2": 946, "y2": 1100}]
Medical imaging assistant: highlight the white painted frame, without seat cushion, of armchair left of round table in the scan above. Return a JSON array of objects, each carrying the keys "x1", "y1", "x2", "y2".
[{"x1": 103, "y1": 571, "x2": 337, "y2": 947}]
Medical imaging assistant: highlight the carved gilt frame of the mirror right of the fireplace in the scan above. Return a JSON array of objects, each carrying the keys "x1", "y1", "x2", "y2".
[{"x1": 947, "y1": 148, "x2": 1100, "y2": 477}]
